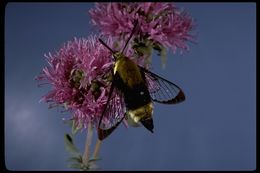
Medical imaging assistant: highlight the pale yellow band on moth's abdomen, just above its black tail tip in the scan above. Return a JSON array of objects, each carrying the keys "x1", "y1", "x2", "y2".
[{"x1": 128, "y1": 102, "x2": 153, "y2": 123}]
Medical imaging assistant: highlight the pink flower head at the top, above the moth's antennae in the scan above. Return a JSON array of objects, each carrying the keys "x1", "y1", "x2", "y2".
[{"x1": 89, "y1": 2, "x2": 193, "y2": 53}]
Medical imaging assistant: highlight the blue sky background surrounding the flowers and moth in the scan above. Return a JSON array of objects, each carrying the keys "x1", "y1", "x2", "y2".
[{"x1": 5, "y1": 3, "x2": 256, "y2": 170}]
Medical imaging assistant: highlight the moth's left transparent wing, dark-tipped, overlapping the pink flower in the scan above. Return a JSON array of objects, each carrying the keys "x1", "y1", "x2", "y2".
[{"x1": 98, "y1": 79, "x2": 126, "y2": 140}]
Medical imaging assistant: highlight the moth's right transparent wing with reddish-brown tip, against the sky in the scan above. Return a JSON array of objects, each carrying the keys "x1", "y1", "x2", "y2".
[{"x1": 140, "y1": 67, "x2": 185, "y2": 104}]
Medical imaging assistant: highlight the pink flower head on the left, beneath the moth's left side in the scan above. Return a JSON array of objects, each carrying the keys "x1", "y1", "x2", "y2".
[{"x1": 37, "y1": 36, "x2": 125, "y2": 128}]
